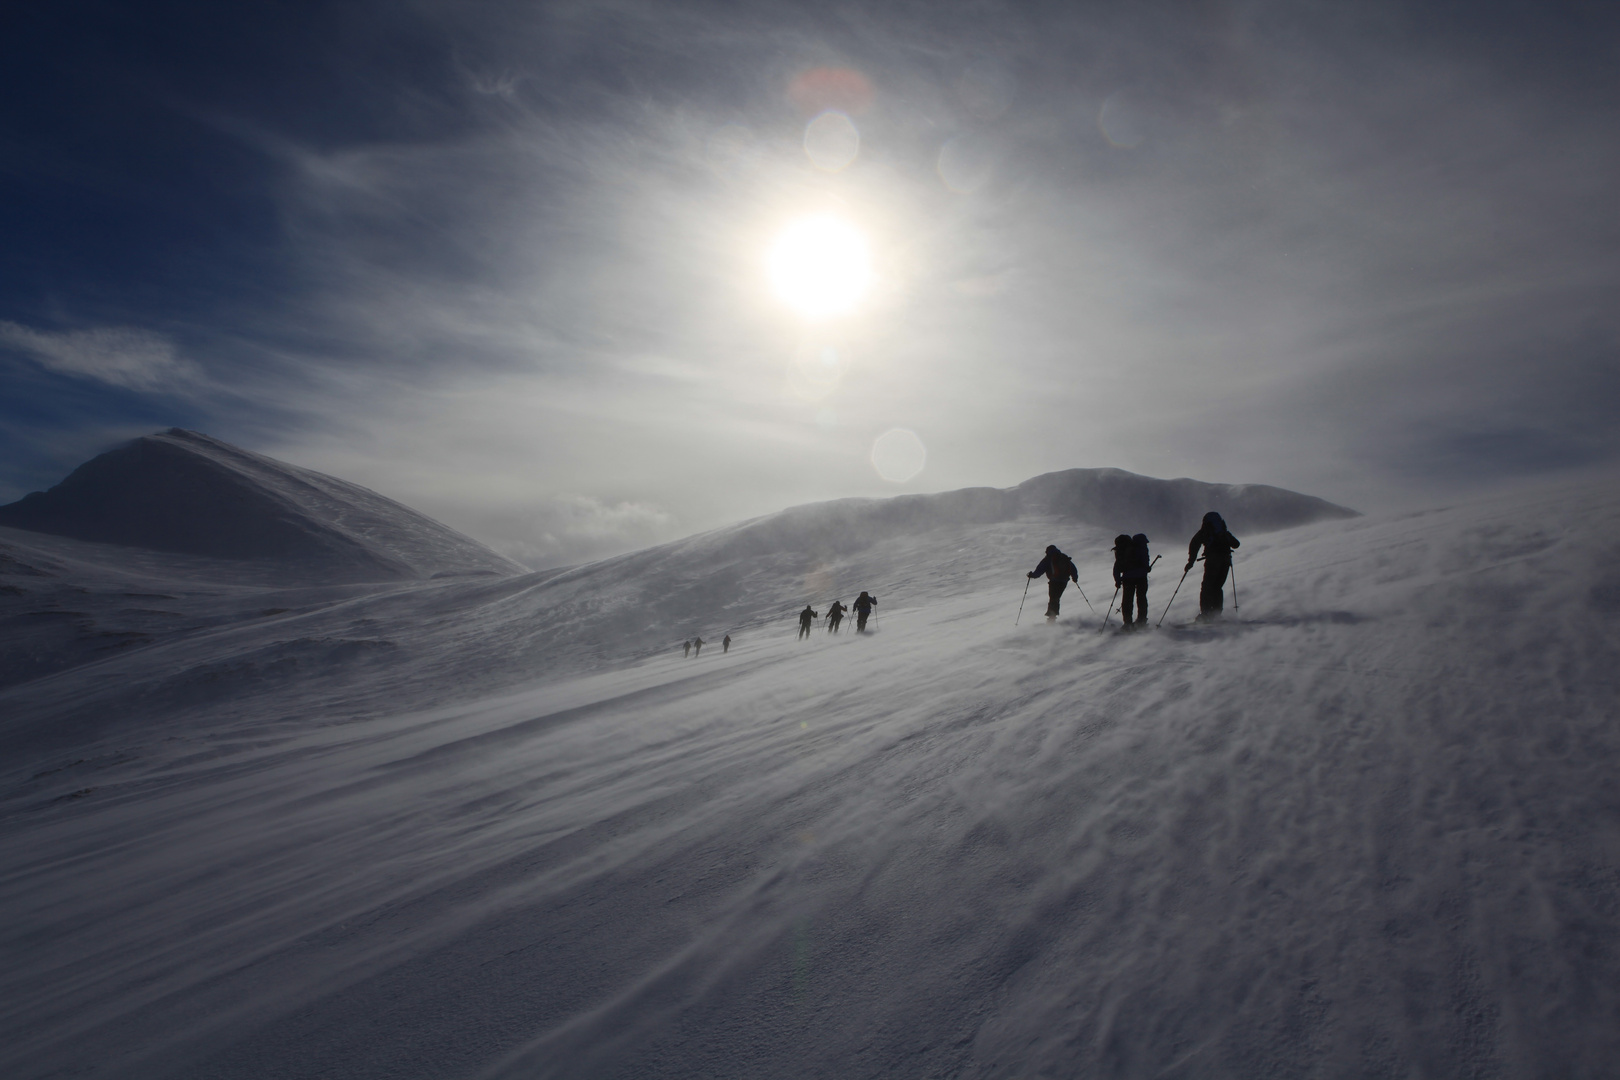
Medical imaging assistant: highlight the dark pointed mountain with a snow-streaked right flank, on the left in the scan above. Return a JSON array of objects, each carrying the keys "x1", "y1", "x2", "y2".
[{"x1": 0, "y1": 427, "x2": 525, "y2": 583}]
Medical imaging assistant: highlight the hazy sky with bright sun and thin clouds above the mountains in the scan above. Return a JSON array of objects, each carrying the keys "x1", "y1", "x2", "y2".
[{"x1": 0, "y1": 0, "x2": 1620, "y2": 567}]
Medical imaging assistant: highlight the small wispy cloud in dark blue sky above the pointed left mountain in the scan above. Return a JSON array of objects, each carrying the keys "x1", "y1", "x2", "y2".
[{"x1": 0, "y1": 319, "x2": 201, "y2": 392}]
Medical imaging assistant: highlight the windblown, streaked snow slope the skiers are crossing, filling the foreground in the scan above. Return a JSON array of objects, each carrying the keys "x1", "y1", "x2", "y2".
[{"x1": 0, "y1": 481, "x2": 1620, "y2": 1080}]
